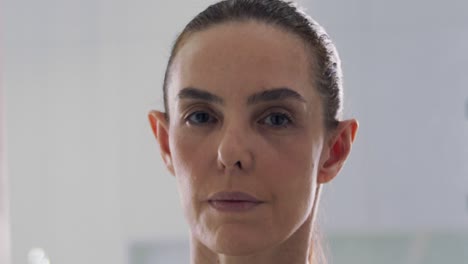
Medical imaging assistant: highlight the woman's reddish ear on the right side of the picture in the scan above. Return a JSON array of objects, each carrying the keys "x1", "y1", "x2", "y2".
[{"x1": 317, "y1": 119, "x2": 359, "y2": 183}]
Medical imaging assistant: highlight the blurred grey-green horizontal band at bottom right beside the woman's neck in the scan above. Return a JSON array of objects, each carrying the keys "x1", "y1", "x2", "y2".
[{"x1": 327, "y1": 233, "x2": 468, "y2": 264}]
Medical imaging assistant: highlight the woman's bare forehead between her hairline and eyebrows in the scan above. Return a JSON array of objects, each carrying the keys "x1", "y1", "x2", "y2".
[{"x1": 168, "y1": 21, "x2": 315, "y2": 103}]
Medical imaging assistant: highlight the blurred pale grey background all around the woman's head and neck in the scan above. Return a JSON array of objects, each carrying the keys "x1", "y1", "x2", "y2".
[{"x1": 0, "y1": 0, "x2": 468, "y2": 264}]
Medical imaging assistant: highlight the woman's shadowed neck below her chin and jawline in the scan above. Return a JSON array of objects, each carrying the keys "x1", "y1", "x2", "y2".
[{"x1": 190, "y1": 214, "x2": 313, "y2": 264}]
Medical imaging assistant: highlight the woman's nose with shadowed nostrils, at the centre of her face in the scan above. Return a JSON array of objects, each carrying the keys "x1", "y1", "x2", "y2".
[{"x1": 218, "y1": 126, "x2": 254, "y2": 172}]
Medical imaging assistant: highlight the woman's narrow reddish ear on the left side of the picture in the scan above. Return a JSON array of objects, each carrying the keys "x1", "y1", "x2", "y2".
[{"x1": 148, "y1": 110, "x2": 175, "y2": 175}]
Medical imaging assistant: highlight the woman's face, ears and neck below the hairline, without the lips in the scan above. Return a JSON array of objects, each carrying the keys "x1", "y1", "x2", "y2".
[{"x1": 149, "y1": 21, "x2": 357, "y2": 264}]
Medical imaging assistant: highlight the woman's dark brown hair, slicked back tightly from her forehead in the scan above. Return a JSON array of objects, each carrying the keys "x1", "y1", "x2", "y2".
[{"x1": 163, "y1": 0, "x2": 343, "y2": 131}]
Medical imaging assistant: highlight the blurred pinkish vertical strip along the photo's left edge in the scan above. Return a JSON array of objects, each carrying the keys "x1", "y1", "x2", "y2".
[{"x1": 0, "y1": 26, "x2": 11, "y2": 264}]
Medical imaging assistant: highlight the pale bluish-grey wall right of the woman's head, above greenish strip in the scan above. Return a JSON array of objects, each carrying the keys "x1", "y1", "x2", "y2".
[{"x1": 310, "y1": 0, "x2": 468, "y2": 230}]
